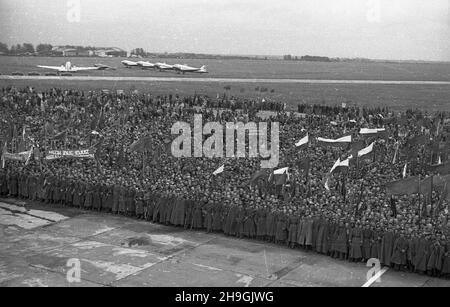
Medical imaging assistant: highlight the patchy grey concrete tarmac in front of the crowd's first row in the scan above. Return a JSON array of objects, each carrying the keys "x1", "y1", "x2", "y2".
[{"x1": 0, "y1": 199, "x2": 450, "y2": 287}]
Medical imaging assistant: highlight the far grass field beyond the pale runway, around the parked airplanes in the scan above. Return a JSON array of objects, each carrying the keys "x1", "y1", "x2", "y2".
[{"x1": 0, "y1": 57, "x2": 450, "y2": 81}]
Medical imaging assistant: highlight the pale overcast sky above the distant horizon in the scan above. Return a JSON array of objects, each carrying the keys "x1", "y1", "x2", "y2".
[{"x1": 0, "y1": 0, "x2": 450, "y2": 61}]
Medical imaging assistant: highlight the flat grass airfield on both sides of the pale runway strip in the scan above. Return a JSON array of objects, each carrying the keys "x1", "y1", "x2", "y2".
[{"x1": 0, "y1": 57, "x2": 450, "y2": 111}]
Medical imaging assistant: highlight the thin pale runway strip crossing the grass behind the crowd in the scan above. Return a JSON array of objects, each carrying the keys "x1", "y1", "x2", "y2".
[{"x1": 0, "y1": 75, "x2": 450, "y2": 85}]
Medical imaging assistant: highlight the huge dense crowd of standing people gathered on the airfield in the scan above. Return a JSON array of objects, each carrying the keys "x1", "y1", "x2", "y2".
[{"x1": 0, "y1": 87, "x2": 450, "y2": 276}]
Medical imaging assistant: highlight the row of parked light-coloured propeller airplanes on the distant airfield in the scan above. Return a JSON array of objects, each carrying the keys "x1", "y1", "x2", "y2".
[{"x1": 37, "y1": 60, "x2": 208, "y2": 74}]
